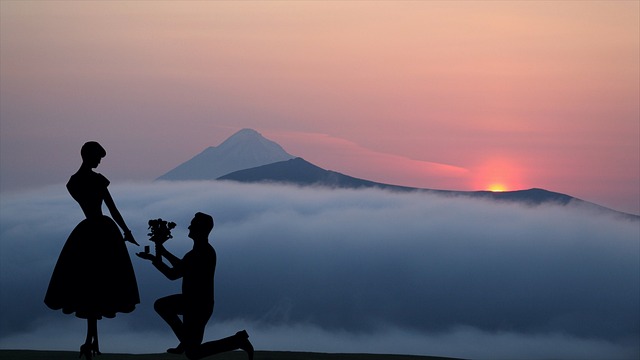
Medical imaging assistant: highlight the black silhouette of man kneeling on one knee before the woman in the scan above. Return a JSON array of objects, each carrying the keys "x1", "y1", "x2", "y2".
[{"x1": 137, "y1": 212, "x2": 253, "y2": 359}]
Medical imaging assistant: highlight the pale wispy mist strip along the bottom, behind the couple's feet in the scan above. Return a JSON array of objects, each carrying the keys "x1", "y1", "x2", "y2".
[{"x1": 0, "y1": 317, "x2": 635, "y2": 360}]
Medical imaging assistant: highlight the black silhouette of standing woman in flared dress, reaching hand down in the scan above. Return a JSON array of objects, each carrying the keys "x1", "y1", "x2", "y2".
[{"x1": 44, "y1": 141, "x2": 140, "y2": 360}]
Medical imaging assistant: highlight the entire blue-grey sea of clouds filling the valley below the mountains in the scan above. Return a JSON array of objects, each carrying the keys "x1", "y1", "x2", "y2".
[{"x1": 0, "y1": 182, "x2": 640, "y2": 359}]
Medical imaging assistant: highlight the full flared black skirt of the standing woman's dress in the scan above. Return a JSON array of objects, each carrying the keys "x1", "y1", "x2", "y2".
[{"x1": 44, "y1": 216, "x2": 140, "y2": 319}]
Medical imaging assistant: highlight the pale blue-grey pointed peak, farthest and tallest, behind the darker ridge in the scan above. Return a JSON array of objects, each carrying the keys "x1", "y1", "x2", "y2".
[{"x1": 158, "y1": 129, "x2": 294, "y2": 181}]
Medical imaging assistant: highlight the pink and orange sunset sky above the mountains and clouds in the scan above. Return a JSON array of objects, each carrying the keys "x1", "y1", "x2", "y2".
[{"x1": 0, "y1": 1, "x2": 640, "y2": 214}]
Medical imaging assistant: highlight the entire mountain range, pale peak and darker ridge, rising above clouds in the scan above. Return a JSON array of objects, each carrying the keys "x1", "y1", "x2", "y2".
[{"x1": 157, "y1": 129, "x2": 640, "y2": 220}]
